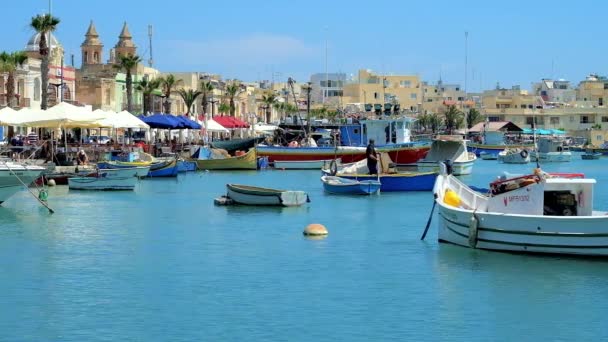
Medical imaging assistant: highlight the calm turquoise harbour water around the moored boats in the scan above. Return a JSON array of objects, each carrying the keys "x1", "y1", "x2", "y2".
[{"x1": 0, "y1": 154, "x2": 608, "y2": 341}]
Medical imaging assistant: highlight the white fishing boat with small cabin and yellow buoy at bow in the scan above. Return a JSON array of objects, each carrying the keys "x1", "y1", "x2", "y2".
[{"x1": 432, "y1": 165, "x2": 608, "y2": 256}]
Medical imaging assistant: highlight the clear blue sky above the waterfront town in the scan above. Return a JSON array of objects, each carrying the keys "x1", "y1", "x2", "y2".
[{"x1": 0, "y1": 0, "x2": 608, "y2": 91}]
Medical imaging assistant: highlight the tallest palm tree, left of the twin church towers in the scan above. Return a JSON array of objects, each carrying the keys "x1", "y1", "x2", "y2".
[{"x1": 30, "y1": 14, "x2": 60, "y2": 109}]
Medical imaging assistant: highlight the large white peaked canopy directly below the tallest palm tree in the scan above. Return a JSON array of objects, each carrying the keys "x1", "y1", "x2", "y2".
[{"x1": 15, "y1": 102, "x2": 106, "y2": 128}]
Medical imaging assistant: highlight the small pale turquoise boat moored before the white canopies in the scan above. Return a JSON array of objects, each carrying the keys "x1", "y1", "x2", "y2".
[{"x1": 68, "y1": 168, "x2": 138, "y2": 190}]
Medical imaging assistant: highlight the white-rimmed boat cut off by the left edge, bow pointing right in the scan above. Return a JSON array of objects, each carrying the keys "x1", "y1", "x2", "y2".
[{"x1": 0, "y1": 161, "x2": 45, "y2": 204}]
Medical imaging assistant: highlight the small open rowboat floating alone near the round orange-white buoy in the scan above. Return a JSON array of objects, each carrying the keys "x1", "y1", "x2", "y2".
[{"x1": 226, "y1": 184, "x2": 309, "y2": 207}]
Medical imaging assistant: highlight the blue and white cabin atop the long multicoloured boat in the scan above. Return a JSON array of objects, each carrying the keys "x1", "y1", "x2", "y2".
[{"x1": 340, "y1": 118, "x2": 414, "y2": 146}]
